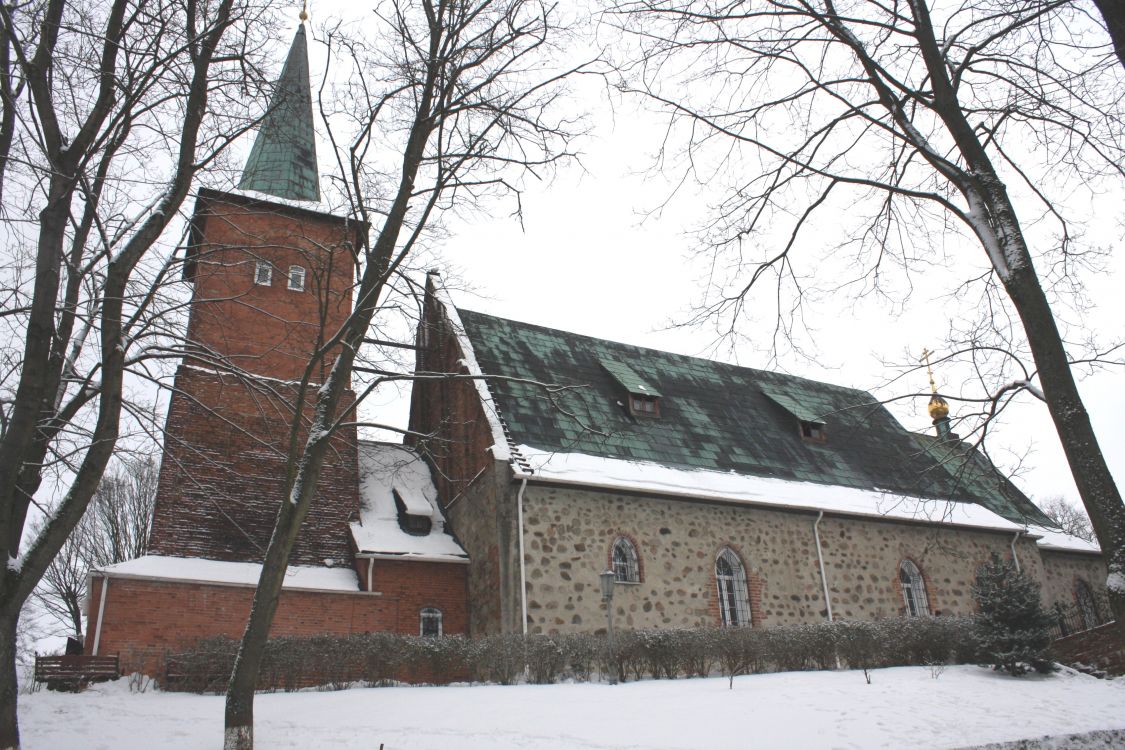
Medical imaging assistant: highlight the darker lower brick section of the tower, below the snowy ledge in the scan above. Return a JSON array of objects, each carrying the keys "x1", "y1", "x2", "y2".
[{"x1": 150, "y1": 365, "x2": 359, "y2": 564}]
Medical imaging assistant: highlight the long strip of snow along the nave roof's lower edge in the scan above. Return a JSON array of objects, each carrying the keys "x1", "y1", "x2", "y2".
[{"x1": 519, "y1": 445, "x2": 1023, "y2": 532}]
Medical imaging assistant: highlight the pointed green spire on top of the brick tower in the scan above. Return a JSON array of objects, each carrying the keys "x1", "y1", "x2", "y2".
[{"x1": 239, "y1": 24, "x2": 321, "y2": 200}]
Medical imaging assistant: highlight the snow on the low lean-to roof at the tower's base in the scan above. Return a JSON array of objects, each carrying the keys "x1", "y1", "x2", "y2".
[{"x1": 98, "y1": 554, "x2": 360, "y2": 591}]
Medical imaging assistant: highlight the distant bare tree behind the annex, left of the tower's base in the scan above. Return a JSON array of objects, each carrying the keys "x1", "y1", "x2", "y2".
[{"x1": 33, "y1": 458, "x2": 159, "y2": 640}]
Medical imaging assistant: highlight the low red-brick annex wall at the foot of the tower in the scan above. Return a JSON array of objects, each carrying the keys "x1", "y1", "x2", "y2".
[{"x1": 86, "y1": 561, "x2": 468, "y2": 676}]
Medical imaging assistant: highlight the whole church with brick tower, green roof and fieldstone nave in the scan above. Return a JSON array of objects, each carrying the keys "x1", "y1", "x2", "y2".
[{"x1": 86, "y1": 20, "x2": 1106, "y2": 675}]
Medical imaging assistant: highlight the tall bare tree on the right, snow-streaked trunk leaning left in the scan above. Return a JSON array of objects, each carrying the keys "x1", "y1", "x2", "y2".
[{"x1": 610, "y1": 0, "x2": 1125, "y2": 627}]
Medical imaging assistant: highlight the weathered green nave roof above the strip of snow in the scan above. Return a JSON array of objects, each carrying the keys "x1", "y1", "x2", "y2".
[{"x1": 459, "y1": 310, "x2": 1044, "y2": 523}]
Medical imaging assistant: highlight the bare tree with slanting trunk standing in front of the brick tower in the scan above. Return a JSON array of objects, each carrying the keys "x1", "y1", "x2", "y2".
[{"x1": 224, "y1": 0, "x2": 589, "y2": 750}]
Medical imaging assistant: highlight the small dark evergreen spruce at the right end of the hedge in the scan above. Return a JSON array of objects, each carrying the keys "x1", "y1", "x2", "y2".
[{"x1": 973, "y1": 552, "x2": 1052, "y2": 677}]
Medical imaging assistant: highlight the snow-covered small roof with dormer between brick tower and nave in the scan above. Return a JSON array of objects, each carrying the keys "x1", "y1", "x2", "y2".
[{"x1": 350, "y1": 442, "x2": 468, "y2": 562}]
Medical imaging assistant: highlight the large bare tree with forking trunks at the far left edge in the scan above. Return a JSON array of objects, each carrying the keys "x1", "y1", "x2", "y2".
[{"x1": 0, "y1": 0, "x2": 280, "y2": 748}]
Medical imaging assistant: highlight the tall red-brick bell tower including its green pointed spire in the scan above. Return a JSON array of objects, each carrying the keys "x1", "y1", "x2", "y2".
[{"x1": 150, "y1": 25, "x2": 359, "y2": 566}]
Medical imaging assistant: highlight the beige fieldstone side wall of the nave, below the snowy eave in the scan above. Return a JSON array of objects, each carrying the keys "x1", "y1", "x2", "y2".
[{"x1": 524, "y1": 485, "x2": 1043, "y2": 633}]
